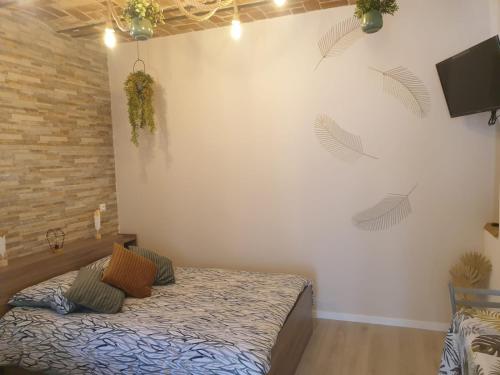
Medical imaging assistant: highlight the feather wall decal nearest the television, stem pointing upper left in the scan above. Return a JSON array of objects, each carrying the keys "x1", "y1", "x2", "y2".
[{"x1": 371, "y1": 66, "x2": 431, "y2": 117}]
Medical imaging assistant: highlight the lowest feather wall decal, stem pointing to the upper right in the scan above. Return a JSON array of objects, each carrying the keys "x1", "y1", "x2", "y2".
[{"x1": 353, "y1": 185, "x2": 417, "y2": 231}]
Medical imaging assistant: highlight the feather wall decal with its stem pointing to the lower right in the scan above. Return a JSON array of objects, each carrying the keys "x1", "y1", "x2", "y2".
[{"x1": 314, "y1": 115, "x2": 378, "y2": 161}]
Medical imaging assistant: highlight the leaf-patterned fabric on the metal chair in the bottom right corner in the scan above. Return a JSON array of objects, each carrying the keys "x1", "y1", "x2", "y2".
[{"x1": 439, "y1": 309, "x2": 500, "y2": 375}]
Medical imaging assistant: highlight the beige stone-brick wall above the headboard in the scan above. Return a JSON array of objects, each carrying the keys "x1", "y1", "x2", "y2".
[{"x1": 0, "y1": 9, "x2": 118, "y2": 257}]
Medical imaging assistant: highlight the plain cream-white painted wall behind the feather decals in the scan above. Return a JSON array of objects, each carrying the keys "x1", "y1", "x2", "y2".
[{"x1": 109, "y1": 0, "x2": 495, "y2": 328}]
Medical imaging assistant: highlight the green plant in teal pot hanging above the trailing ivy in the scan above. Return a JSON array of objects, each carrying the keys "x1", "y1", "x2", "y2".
[{"x1": 123, "y1": 0, "x2": 165, "y2": 40}]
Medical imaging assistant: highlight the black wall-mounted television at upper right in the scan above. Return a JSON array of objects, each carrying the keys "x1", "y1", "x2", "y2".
[{"x1": 437, "y1": 35, "x2": 500, "y2": 117}]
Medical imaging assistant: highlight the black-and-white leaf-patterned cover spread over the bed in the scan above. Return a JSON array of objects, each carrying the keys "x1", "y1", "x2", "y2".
[{"x1": 0, "y1": 268, "x2": 308, "y2": 375}]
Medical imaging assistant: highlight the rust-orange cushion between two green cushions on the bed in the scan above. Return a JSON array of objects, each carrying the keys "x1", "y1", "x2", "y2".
[{"x1": 102, "y1": 244, "x2": 158, "y2": 298}]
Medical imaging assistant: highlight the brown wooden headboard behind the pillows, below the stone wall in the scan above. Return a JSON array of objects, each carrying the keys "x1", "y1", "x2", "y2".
[{"x1": 0, "y1": 234, "x2": 137, "y2": 316}]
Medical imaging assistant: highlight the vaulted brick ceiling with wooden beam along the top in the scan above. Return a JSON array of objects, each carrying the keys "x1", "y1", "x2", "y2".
[{"x1": 0, "y1": 0, "x2": 356, "y2": 40}]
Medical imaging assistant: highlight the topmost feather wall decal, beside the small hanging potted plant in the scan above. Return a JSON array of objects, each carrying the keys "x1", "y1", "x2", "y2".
[{"x1": 314, "y1": 16, "x2": 363, "y2": 70}]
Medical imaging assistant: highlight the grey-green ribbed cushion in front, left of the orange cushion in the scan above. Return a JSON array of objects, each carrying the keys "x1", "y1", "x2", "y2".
[{"x1": 64, "y1": 268, "x2": 125, "y2": 314}]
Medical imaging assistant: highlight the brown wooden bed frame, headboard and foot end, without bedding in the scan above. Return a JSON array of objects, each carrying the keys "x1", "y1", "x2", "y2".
[{"x1": 0, "y1": 234, "x2": 313, "y2": 375}]
